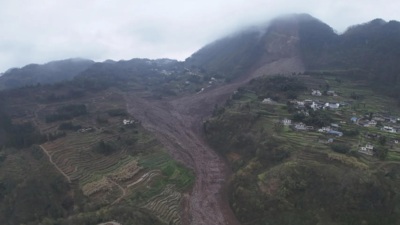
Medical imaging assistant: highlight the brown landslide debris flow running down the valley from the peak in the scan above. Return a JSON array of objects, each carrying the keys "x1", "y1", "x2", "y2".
[{"x1": 125, "y1": 22, "x2": 304, "y2": 225}]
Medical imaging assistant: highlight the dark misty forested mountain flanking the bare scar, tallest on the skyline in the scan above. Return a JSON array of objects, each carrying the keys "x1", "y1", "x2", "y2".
[{"x1": 186, "y1": 14, "x2": 400, "y2": 91}]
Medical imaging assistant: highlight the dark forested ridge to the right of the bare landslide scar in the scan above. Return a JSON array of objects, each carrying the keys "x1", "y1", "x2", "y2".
[{"x1": 299, "y1": 19, "x2": 400, "y2": 80}]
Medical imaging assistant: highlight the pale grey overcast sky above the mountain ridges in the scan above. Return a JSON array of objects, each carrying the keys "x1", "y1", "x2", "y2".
[{"x1": 0, "y1": 0, "x2": 400, "y2": 72}]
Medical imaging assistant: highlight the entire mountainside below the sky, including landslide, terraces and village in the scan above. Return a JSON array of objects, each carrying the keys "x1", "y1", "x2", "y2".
[{"x1": 0, "y1": 14, "x2": 400, "y2": 225}]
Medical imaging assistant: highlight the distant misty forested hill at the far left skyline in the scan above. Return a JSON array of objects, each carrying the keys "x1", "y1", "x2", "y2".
[{"x1": 0, "y1": 58, "x2": 94, "y2": 89}]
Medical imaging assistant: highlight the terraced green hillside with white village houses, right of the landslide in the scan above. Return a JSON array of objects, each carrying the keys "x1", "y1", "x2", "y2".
[{"x1": 204, "y1": 74, "x2": 400, "y2": 224}]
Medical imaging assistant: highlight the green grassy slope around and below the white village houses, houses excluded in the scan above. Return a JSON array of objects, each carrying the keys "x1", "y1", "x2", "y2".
[{"x1": 205, "y1": 73, "x2": 400, "y2": 224}]
